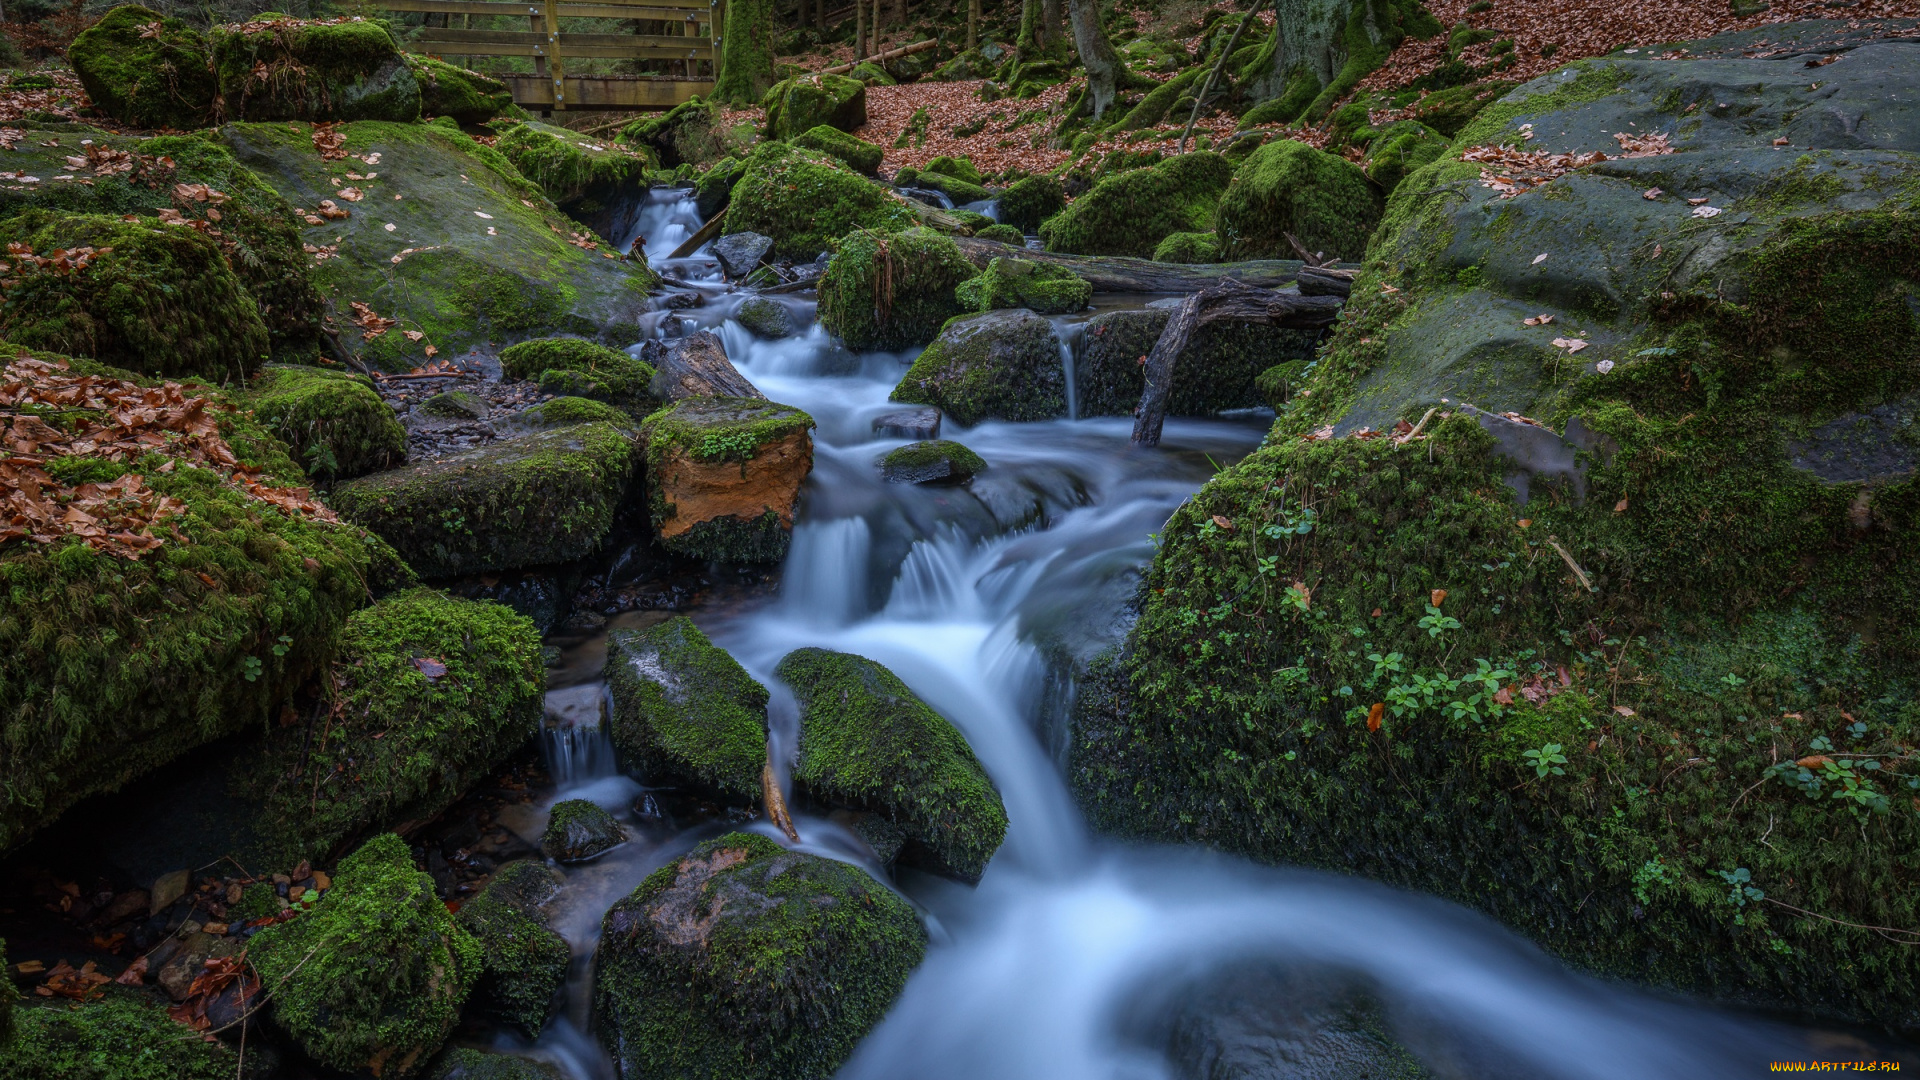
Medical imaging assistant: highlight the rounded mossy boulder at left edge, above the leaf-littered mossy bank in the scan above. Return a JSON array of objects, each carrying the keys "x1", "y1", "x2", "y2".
[{"x1": 0, "y1": 209, "x2": 269, "y2": 380}]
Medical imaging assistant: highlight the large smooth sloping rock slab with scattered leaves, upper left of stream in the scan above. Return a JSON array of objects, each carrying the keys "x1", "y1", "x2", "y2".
[{"x1": 217, "y1": 121, "x2": 659, "y2": 371}]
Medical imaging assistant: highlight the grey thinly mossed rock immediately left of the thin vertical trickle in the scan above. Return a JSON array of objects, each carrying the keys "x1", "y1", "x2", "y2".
[{"x1": 889, "y1": 307, "x2": 1068, "y2": 427}]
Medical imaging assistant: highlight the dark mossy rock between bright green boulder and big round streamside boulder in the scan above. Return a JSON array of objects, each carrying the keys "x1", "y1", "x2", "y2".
[{"x1": 453, "y1": 861, "x2": 572, "y2": 1038}]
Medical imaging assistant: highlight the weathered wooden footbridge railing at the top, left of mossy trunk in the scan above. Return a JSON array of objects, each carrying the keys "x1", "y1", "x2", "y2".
[{"x1": 378, "y1": 0, "x2": 722, "y2": 111}]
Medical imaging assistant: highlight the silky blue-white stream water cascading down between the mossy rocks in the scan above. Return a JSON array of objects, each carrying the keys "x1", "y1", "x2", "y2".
[{"x1": 509, "y1": 184, "x2": 1889, "y2": 1080}]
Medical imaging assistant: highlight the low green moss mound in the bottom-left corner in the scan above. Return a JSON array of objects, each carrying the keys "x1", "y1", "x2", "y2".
[{"x1": 0, "y1": 988, "x2": 240, "y2": 1080}]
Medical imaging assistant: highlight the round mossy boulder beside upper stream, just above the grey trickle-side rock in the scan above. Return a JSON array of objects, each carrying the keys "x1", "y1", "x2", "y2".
[{"x1": 820, "y1": 229, "x2": 979, "y2": 352}]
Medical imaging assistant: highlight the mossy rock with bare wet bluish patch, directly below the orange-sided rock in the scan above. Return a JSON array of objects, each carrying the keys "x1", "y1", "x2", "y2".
[{"x1": 605, "y1": 615, "x2": 768, "y2": 799}]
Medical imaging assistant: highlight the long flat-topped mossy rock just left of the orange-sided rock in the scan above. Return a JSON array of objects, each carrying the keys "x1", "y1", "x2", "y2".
[{"x1": 330, "y1": 423, "x2": 639, "y2": 578}]
